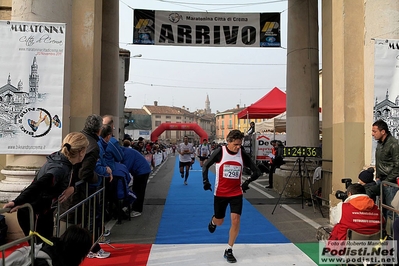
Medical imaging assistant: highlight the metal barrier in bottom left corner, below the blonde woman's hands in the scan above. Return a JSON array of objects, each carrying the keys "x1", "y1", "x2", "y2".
[{"x1": 0, "y1": 203, "x2": 35, "y2": 266}]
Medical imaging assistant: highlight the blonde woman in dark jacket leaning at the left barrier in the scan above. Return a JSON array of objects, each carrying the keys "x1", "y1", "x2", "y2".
[{"x1": 3, "y1": 132, "x2": 89, "y2": 238}]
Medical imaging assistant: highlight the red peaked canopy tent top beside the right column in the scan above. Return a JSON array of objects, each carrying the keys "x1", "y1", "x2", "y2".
[{"x1": 238, "y1": 87, "x2": 286, "y2": 119}]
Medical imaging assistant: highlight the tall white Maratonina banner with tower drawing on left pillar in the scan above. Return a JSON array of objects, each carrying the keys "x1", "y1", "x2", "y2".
[{"x1": 0, "y1": 21, "x2": 65, "y2": 154}]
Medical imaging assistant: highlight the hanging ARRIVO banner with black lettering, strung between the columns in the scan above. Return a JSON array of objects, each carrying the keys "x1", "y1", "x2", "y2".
[{"x1": 133, "y1": 9, "x2": 281, "y2": 47}]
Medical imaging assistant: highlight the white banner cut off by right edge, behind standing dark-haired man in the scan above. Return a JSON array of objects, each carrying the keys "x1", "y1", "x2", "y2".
[{"x1": 371, "y1": 39, "x2": 399, "y2": 164}]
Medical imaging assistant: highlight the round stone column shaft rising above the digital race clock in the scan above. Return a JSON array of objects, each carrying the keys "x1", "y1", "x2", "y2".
[{"x1": 287, "y1": 0, "x2": 319, "y2": 147}]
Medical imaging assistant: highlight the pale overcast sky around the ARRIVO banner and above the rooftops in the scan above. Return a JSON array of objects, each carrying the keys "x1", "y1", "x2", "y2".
[{"x1": 119, "y1": 0, "x2": 288, "y2": 112}]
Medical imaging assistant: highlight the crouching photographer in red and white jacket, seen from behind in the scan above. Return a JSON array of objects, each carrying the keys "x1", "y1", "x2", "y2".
[{"x1": 328, "y1": 184, "x2": 381, "y2": 240}]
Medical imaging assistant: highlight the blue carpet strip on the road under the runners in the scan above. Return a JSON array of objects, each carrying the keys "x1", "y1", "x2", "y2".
[{"x1": 155, "y1": 156, "x2": 290, "y2": 244}]
